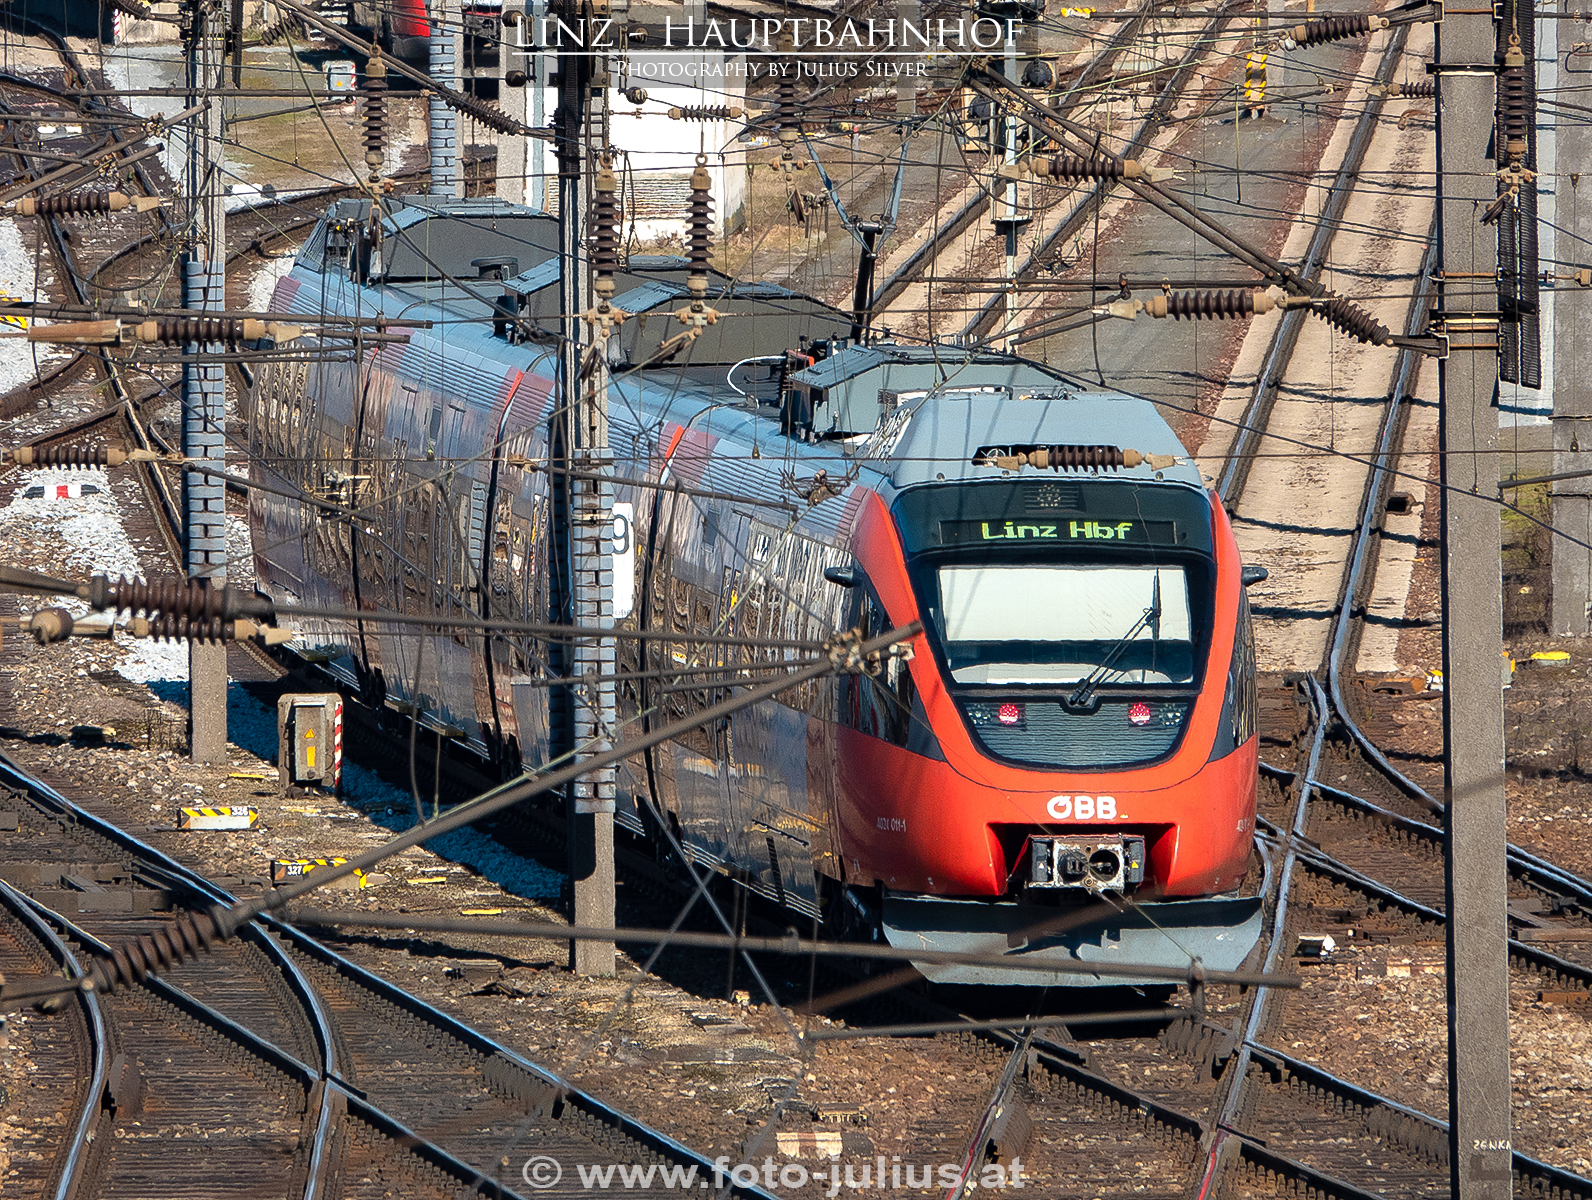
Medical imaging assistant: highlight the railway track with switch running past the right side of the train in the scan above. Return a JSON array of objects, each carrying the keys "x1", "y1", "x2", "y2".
[{"x1": 872, "y1": 14, "x2": 1592, "y2": 1197}]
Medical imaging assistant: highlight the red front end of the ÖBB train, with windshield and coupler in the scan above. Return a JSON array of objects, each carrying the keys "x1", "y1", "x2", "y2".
[{"x1": 834, "y1": 482, "x2": 1259, "y2": 984}]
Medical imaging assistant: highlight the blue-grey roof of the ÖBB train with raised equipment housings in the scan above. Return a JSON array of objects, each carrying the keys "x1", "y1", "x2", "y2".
[{"x1": 283, "y1": 197, "x2": 1204, "y2": 538}]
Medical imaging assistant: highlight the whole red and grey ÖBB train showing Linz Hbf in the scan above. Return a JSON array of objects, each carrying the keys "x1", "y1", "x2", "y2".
[{"x1": 248, "y1": 197, "x2": 1259, "y2": 985}]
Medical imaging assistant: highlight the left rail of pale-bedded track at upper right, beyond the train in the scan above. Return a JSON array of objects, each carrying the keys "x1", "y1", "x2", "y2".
[{"x1": 1216, "y1": 25, "x2": 1430, "y2": 499}]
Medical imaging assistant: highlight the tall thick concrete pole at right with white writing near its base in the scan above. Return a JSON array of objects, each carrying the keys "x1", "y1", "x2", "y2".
[{"x1": 1436, "y1": 6, "x2": 1512, "y2": 1200}]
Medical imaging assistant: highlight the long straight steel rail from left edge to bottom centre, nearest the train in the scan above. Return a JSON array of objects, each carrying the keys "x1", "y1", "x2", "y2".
[{"x1": 0, "y1": 751, "x2": 778, "y2": 1200}]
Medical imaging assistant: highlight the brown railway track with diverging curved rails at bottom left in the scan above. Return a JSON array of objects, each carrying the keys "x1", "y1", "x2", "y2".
[{"x1": 0, "y1": 738, "x2": 766, "y2": 1195}]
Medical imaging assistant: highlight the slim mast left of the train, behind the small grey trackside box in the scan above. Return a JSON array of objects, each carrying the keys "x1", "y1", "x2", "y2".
[{"x1": 181, "y1": 0, "x2": 226, "y2": 764}]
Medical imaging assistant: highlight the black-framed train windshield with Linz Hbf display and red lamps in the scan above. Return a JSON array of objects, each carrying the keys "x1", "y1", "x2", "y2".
[{"x1": 895, "y1": 479, "x2": 1216, "y2": 770}]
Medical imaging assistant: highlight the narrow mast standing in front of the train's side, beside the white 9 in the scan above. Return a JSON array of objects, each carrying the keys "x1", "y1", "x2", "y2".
[{"x1": 552, "y1": 28, "x2": 616, "y2": 976}]
